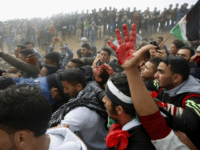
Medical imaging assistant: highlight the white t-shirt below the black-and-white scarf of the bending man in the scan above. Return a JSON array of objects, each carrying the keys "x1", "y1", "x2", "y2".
[{"x1": 61, "y1": 107, "x2": 107, "y2": 150}]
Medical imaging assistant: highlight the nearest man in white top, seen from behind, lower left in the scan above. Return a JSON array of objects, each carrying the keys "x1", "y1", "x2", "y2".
[{"x1": 0, "y1": 84, "x2": 86, "y2": 150}]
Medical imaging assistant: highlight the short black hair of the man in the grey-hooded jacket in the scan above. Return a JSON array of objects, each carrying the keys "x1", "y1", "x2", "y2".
[{"x1": 162, "y1": 55, "x2": 190, "y2": 82}]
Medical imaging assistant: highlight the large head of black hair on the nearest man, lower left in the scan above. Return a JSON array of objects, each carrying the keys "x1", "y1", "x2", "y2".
[{"x1": 0, "y1": 84, "x2": 52, "y2": 138}]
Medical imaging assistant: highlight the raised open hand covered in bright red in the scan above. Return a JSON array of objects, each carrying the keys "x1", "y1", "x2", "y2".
[{"x1": 108, "y1": 24, "x2": 136, "y2": 65}]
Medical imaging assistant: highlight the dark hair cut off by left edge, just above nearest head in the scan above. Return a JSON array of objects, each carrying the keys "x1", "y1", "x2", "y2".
[{"x1": 0, "y1": 76, "x2": 16, "y2": 90}]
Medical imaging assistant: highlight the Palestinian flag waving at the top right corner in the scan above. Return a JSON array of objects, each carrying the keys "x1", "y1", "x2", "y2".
[{"x1": 170, "y1": 0, "x2": 200, "y2": 41}]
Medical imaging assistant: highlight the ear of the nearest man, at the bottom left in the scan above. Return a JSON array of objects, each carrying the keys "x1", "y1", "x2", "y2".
[{"x1": 14, "y1": 131, "x2": 31, "y2": 149}]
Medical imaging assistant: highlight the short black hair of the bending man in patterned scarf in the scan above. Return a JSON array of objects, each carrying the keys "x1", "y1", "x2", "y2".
[{"x1": 59, "y1": 68, "x2": 86, "y2": 88}]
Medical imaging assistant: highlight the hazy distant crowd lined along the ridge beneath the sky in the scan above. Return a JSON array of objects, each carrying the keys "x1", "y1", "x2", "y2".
[{"x1": 0, "y1": 3, "x2": 192, "y2": 51}]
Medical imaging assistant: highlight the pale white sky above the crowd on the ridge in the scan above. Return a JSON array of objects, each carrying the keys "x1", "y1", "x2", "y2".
[{"x1": 0, "y1": 0, "x2": 198, "y2": 21}]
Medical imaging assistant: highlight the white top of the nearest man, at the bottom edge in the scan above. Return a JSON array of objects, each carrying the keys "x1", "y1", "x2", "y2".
[{"x1": 46, "y1": 128, "x2": 87, "y2": 150}]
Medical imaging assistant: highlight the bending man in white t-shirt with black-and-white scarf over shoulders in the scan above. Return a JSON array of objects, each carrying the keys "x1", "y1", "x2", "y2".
[{"x1": 49, "y1": 68, "x2": 106, "y2": 150}]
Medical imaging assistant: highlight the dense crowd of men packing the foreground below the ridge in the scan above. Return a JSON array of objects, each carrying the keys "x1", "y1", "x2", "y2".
[{"x1": 0, "y1": 4, "x2": 200, "y2": 150}]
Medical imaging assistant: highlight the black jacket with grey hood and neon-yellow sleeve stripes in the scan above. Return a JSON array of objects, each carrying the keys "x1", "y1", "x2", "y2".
[{"x1": 145, "y1": 76, "x2": 200, "y2": 149}]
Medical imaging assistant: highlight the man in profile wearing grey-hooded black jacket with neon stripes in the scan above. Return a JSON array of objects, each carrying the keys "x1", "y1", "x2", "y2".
[{"x1": 146, "y1": 56, "x2": 200, "y2": 148}]
